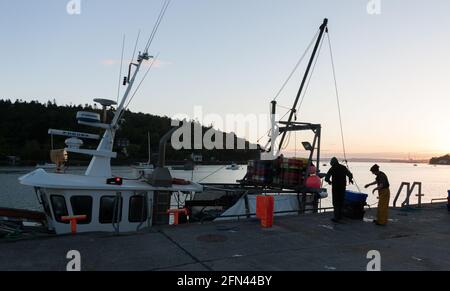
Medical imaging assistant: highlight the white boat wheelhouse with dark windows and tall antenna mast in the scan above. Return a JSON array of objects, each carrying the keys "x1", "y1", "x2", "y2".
[{"x1": 19, "y1": 1, "x2": 203, "y2": 234}]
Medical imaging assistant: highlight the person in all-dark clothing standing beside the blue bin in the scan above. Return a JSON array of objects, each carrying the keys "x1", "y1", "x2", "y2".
[{"x1": 325, "y1": 158, "x2": 353, "y2": 222}]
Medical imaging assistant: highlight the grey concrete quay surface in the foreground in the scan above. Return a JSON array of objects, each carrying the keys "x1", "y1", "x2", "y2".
[{"x1": 0, "y1": 204, "x2": 450, "y2": 271}]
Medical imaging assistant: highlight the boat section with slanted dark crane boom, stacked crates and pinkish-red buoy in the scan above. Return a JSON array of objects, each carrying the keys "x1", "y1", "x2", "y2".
[{"x1": 185, "y1": 19, "x2": 331, "y2": 221}]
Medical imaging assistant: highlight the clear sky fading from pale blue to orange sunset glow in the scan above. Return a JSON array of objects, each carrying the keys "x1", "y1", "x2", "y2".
[{"x1": 0, "y1": 0, "x2": 450, "y2": 158}]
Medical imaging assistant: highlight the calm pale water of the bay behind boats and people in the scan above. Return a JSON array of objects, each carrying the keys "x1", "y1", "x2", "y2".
[{"x1": 0, "y1": 163, "x2": 450, "y2": 210}]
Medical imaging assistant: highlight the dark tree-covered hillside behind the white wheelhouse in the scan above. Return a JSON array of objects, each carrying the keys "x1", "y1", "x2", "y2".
[{"x1": 0, "y1": 100, "x2": 258, "y2": 164}]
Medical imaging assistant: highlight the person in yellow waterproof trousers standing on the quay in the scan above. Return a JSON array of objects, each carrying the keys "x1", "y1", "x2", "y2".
[{"x1": 365, "y1": 164, "x2": 391, "y2": 225}]
